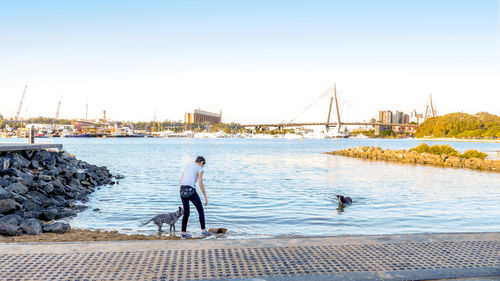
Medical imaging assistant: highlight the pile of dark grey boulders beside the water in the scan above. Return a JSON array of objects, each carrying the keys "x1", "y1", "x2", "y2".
[{"x1": 0, "y1": 150, "x2": 114, "y2": 236}]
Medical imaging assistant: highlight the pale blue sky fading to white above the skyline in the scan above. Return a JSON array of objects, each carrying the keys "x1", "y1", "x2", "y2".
[{"x1": 0, "y1": 0, "x2": 500, "y2": 124}]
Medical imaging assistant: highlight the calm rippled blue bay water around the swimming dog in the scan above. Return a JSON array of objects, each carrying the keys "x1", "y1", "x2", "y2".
[{"x1": 1, "y1": 138, "x2": 500, "y2": 238}]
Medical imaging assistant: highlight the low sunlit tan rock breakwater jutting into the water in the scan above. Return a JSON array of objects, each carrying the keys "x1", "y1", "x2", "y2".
[{"x1": 326, "y1": 146, "x2": 500, "y2": 172}]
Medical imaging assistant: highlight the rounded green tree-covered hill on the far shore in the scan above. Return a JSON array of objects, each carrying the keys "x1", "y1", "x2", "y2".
[{"x1": 416, "y1": 112, "x2": 500, "y2": 138}]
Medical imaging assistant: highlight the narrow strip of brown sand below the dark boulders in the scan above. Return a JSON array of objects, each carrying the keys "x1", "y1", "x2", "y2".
[{"x1": 0, "y1": 229, "x2": 190, "y2": 243}]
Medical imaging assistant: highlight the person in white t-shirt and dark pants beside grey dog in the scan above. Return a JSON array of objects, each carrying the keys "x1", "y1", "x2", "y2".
[{"x1": 180, "y1": 156, "x2": 210, "y2": 239}]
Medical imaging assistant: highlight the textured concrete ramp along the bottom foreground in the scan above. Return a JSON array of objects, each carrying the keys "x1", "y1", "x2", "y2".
[{"x1": 0, "y1": 232, "x2": 500, "y2": 281}]
